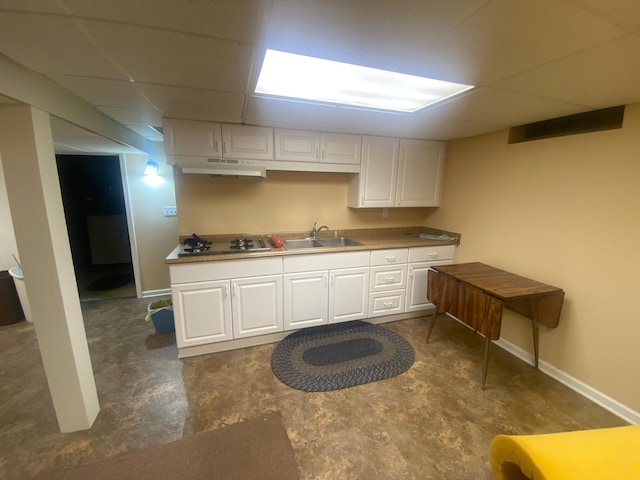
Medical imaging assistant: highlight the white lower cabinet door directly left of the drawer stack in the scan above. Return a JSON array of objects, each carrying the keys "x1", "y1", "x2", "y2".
[{"x1": 329, "y1": 267, "x2": 369, "y2": 323}]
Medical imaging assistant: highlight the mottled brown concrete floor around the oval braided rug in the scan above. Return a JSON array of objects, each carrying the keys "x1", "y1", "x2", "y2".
[{"x1": 0, "y1": 298, "x2": 625, "y2": 480}]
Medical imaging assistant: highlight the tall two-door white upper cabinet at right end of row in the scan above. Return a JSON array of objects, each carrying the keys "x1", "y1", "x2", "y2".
[{"x1": 348, "y1": 136, "x2": 446, "y2": 208}]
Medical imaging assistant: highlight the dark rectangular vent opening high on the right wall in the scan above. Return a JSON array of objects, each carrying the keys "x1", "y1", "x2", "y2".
[{"x1": 509, "y1": 105, "x2": 624, "y2": 143}]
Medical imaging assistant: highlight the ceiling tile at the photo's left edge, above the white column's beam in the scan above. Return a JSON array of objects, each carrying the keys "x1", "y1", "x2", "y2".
[{"x1": 0, "y1": 12, "x2": 126, "y2": 79}]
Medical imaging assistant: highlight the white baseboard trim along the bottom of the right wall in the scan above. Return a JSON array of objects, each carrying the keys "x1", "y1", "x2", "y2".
[{"x1": 493, "y1": 338, "x2": 640, "y2": 425}]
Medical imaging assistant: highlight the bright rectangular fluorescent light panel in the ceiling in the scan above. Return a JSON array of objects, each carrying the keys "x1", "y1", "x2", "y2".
[{"x1": 256, "y1": 50, "x2": 473, "y2": 113}]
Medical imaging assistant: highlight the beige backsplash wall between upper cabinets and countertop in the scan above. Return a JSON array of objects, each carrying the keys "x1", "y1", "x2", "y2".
[{"x1": 175, "y1": 171, "x2": 433, "y2": 235}]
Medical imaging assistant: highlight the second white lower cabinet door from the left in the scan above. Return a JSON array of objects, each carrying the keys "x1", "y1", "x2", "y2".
[{"x1": 231, "y1": 275, "x2": 282, "y2": 338}]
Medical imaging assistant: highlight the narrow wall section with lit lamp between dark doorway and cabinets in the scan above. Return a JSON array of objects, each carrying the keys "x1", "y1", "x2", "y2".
[{"x1": 124, "y1": 154, "x2": 178, "y2": 293}]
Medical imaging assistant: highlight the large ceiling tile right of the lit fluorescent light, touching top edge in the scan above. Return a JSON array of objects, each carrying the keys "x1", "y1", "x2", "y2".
[{"x1": 424, "y1": 0, "x2": 625, "y2": 86}]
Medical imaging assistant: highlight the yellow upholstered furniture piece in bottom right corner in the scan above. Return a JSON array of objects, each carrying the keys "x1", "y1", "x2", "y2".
[{"x1": 491, "y1": 425, "x2": 640, "y2": 480}]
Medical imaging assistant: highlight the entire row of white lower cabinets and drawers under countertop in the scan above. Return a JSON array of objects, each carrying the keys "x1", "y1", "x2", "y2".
[{"x1": 169, "y1": 245, "x2": 455, "y2": 348}]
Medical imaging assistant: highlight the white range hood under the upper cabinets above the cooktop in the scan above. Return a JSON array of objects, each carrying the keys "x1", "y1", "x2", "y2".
[{"x1": 173, "y1": 155, "x2": 267, "y2": 178}]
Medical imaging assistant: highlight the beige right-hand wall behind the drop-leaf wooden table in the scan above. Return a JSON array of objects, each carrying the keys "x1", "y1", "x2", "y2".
[{"x1": 427, "y1": 104, "x2": 640, "y2": 412}]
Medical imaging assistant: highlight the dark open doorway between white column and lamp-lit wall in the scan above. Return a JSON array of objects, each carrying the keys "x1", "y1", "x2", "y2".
[{"x1": 56, "y1": 155, "x2": 136, "y2": 301}]
